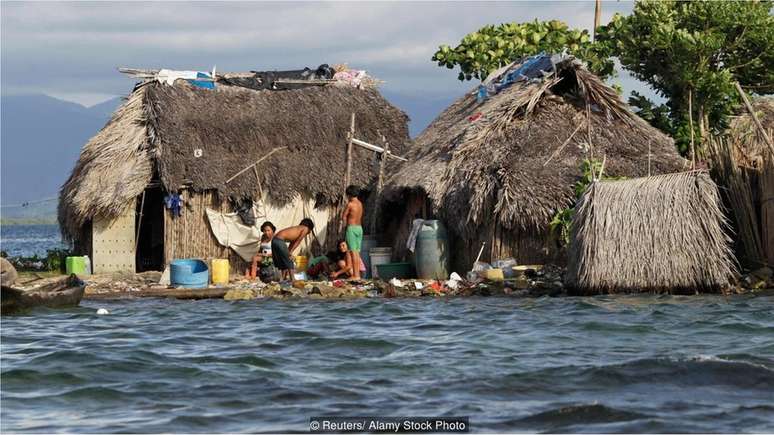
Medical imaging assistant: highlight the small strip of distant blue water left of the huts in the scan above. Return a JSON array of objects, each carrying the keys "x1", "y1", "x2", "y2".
[{"x1": 0, "y1": 225, "x2": 67, "y2": 257}]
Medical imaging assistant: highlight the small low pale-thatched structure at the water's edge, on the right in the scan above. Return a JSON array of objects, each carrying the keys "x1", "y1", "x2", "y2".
[{"x1": 567, "y1": 171, "x2": 736, "y2": 294}]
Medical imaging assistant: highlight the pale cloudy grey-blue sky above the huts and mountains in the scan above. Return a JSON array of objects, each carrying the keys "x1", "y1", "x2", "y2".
[{"x1": 0, "y1": 0, "x2": 650, "y2": 106}]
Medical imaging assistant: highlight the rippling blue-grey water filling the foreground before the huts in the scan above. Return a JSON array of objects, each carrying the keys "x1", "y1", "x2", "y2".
[{"x1": 0, "y1": 295, "x2": 774, "y2": 433}]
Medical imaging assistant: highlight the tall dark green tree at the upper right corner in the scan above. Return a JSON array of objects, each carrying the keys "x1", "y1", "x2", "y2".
[{"x1": 596, "y1": 0, "x2": 774, "y2": 157}]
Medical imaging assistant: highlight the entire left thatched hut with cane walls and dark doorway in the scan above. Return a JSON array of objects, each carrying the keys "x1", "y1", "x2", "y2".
[{"x1": 59, "y1": 73, "x2": 408, "y2": 271}]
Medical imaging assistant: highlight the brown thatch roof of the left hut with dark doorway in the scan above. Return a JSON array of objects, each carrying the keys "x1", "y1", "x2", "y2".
[{"x1": 59, "y1": 76, "x2": 408, "y2": 237}]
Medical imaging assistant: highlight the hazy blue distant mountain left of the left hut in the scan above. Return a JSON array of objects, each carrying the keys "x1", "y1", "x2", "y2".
[{"x1": 0, "y1": 95, "x2": 121, "y2": 217}]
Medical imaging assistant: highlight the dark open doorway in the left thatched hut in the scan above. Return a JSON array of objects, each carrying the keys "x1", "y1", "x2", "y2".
[{"x1": 136, "y1": 186, "x2": 164, "y2": 272}]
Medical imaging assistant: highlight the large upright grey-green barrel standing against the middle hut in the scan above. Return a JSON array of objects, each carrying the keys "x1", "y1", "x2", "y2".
[{"x1": 414, "y1": 220, "x2": 449, "y2": 279}]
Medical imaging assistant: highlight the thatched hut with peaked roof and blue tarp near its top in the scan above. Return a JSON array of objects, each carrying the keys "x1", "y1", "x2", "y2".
[{"x1": 386, "y1": 56, "x2": 685, "y2": 271}]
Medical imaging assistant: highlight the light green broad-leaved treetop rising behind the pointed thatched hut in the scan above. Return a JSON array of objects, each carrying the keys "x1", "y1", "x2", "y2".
[{"x1": 432, "y1": 20, "x2": 613, "y2": 80}]
